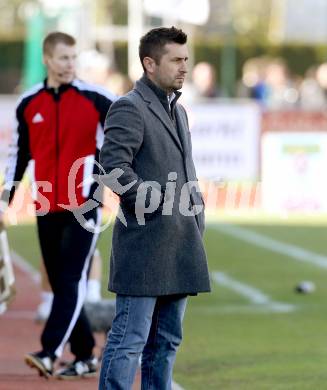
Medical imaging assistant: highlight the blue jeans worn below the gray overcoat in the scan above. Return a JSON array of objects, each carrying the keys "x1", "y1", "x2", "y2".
[{"x1": 99, "y1": 295, "x2": 187, "y2": 390}]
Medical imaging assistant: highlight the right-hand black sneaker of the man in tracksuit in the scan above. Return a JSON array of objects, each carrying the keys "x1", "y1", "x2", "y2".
[{"x1": 55, "y1": 357, "x2": 98, "y2": 380}]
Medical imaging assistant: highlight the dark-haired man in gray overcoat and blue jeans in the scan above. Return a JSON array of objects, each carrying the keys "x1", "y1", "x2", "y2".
[{"x1": 99, "y1": 27, "x2": 210, "y2": 390}]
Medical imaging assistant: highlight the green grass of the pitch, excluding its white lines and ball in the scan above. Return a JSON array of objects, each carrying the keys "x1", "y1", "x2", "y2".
[{"x1": 9, "y1": 224, "x2": 327, "y2": 390}]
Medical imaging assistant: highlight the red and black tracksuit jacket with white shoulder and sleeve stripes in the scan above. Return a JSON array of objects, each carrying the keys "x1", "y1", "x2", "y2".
[{"x1": 2, "y1": 79, "x2": 116, "y2": 212}]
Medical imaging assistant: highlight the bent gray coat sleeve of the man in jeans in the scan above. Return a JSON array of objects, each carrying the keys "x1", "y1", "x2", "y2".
[{"x1": 100, "y1": 97, "x2": 161, "y2": 209}]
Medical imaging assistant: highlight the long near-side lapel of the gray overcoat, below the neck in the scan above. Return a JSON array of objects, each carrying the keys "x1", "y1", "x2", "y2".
[{"x1": 136, "y1": 81, "x2": 183, "y2": 152}]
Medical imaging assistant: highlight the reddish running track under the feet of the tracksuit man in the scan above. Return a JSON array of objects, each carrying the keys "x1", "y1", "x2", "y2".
[{"x1": 0, "y1": 267, "x2": 140, "y2": 390}]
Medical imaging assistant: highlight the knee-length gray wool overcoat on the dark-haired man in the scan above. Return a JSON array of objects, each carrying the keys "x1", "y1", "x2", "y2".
[{"x1": 100, "y1": 79, "x2": 210, "y2": 296}]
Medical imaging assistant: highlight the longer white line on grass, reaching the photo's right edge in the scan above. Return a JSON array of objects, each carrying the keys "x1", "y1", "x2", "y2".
[{"x1": 214, "y1": 224, "x2": 327, "y2": 268}]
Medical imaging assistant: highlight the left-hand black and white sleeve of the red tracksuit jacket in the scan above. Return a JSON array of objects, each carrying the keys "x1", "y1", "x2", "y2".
[{"x1": 1, "y1": 104, "x2": 30, "y2": 204}]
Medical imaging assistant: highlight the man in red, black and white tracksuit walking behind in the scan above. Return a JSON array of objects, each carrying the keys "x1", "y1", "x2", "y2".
[{"x1": 0, "y1": 32, "x2": 115, "y2": 379}]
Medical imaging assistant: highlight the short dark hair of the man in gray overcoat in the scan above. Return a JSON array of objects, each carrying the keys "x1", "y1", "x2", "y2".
[{"x1": 139, "y1": 26, "x2": 187, "y2": 70}]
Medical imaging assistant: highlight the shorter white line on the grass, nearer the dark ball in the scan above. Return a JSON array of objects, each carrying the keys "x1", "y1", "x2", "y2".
[{"x1": 211, "y1": 271, "x2": 295, "y2": 313}]
